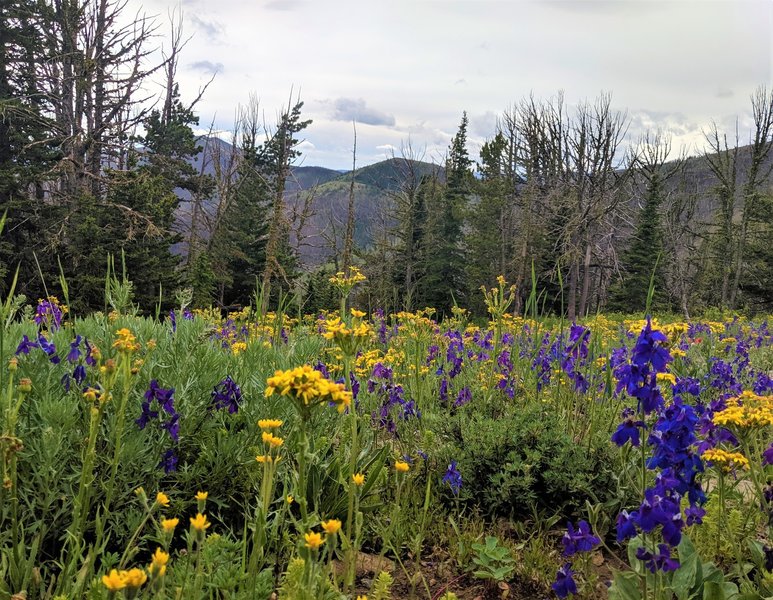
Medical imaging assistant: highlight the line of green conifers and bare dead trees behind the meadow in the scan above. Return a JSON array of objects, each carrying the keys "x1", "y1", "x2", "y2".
[{"x1": 0, "y1": 0, "x2": 773, "y2": 319}]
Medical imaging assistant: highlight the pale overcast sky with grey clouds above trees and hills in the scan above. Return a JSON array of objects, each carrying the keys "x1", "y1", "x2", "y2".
[{"x1": 125, "y1": 0, "x2": 773, "y2": 169}]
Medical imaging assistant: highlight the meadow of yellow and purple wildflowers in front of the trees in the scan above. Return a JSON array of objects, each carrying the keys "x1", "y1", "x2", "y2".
[{"x1": 0, "y1": 269, "x2": 773, "y2": 600}]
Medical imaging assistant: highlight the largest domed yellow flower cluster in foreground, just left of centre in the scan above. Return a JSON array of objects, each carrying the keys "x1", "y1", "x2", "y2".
[{"x1": 265, "y1": 365, "x2": 352, "y2": 412}]
